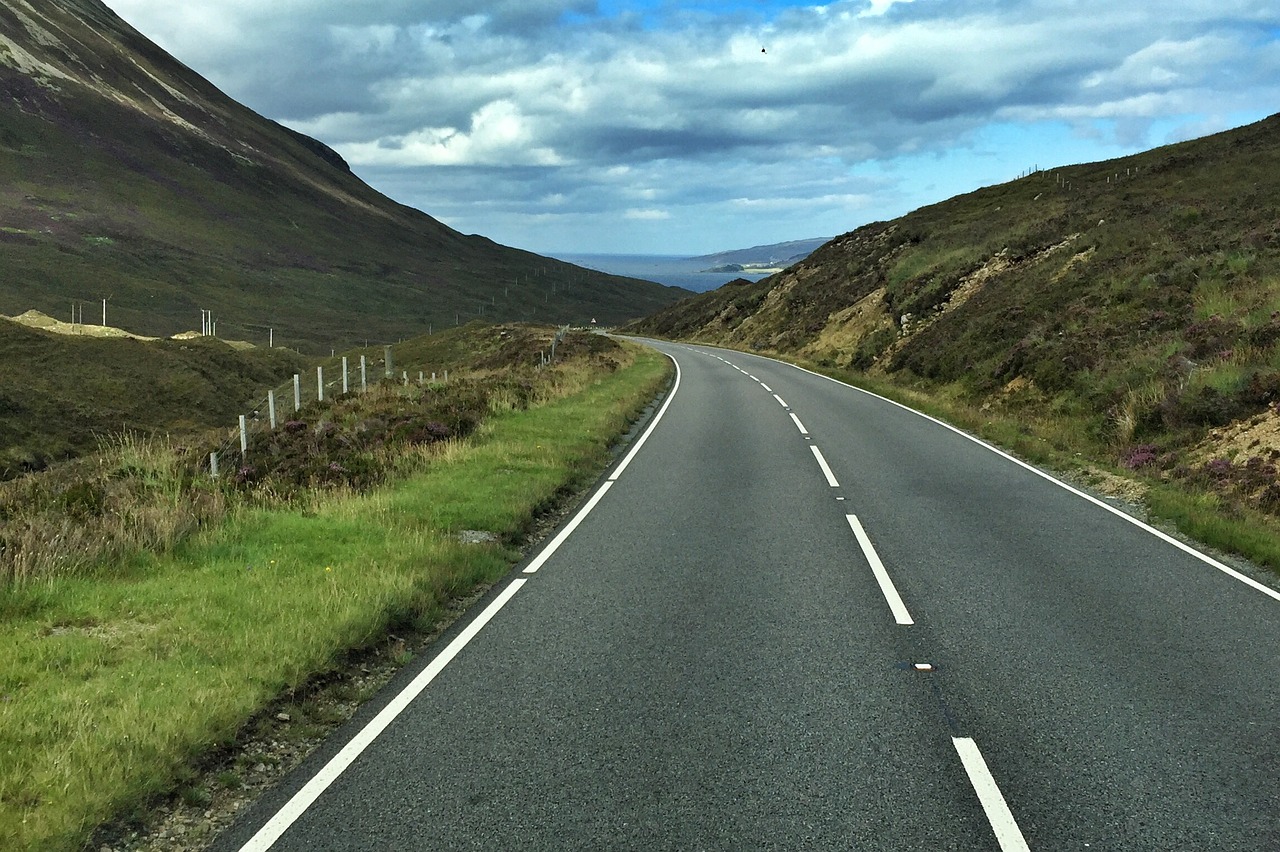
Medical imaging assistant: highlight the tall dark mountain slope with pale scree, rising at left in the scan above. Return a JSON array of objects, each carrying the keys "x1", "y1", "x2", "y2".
[{"x1": 0, "y1": 0, "x2": 684, "y2": 353}]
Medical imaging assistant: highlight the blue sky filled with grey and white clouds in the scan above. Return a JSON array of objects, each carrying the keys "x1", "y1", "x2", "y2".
[{"x1": 106, "y1": 0, "x2": 1280, "y2": 255}]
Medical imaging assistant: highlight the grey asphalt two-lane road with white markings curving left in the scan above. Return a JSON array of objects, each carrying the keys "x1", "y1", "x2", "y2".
[{"x1": 215, "y1": 343, "x2": 1280, "y2": 852}]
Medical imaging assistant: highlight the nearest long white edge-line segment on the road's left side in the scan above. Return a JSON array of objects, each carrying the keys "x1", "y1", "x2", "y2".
[{"x1": 241, "y1": 578, "x2": 529, "y2": 852}]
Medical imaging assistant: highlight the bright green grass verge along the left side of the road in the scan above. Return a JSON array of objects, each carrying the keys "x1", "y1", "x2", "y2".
[{"x1": 0, "y1": 342, "x2": 669, "y2": 849}]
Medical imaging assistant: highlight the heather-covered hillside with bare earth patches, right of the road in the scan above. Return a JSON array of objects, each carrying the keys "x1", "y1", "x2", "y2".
[{"x1": 631, "y1": 116, "x2": 1280, "y2": 509}]
